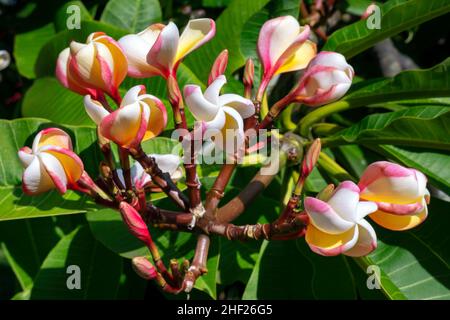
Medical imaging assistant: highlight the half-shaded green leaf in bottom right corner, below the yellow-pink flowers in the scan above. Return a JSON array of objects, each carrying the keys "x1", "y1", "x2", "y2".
[{"x1": 358, "y1": 198, "x2": 450, "y2": 300}]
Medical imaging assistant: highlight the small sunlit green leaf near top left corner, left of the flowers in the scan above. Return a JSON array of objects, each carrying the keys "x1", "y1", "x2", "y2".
[{"x1": 14, "y1": 23, "x2": 56, "y2": 79}]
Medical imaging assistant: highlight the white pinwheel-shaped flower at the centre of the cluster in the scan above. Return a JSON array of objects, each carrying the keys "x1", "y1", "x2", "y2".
[{"x1": 184, "y1": 75, "x2": 255, "y2": 155}]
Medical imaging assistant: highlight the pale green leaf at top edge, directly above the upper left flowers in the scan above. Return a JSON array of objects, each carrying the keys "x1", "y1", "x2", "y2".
[{"x1": 100, "y1": 0, "x2": 162, "y2": 33}]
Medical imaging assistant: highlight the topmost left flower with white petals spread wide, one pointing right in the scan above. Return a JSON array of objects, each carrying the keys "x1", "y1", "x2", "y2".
[{"x1": 119, "y1": 18, "x2": 216, "y2": 78}]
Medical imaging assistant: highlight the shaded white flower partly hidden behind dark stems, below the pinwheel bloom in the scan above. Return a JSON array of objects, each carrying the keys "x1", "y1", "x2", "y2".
[{"x1": 117, "y1": 154, "x2": 183, "y2": 188}]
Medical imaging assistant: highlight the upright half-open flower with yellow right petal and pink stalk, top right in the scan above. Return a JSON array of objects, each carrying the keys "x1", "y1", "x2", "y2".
[{"x1": 258, "y1": 16, "x2": 317, "y2": 98}]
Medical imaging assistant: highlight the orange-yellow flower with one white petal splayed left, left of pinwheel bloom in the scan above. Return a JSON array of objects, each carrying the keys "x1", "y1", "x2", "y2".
[{"x1": 84, "y1": 85, "x2": 167, "y2": 148}]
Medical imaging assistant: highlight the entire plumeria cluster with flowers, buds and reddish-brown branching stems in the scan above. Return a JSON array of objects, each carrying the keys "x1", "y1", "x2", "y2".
[{"x1": 18, "y1": 16, "x2": 429, "y2": 293}]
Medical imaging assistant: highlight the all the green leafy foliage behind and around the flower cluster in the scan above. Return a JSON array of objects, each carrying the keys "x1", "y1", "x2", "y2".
[{"x1": 0, "y1": 0, "x2": 450, "y2": 299}]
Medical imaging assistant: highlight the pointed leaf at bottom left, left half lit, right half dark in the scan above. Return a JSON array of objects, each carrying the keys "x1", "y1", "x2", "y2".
[{"x1": 31, "y1": 227, "x2": 122, "y2": 300}]
